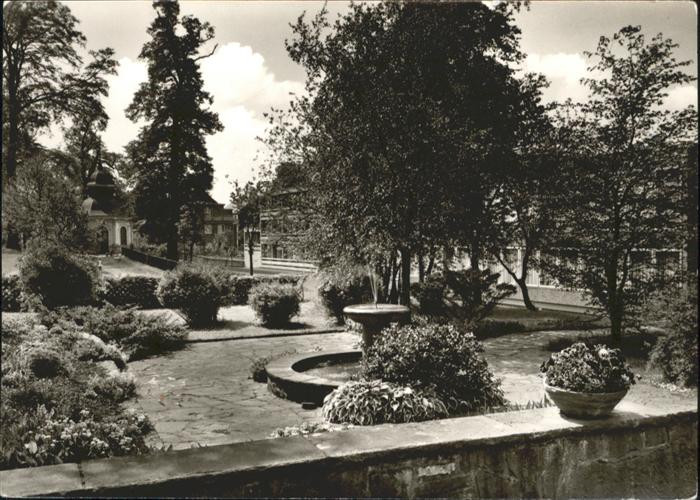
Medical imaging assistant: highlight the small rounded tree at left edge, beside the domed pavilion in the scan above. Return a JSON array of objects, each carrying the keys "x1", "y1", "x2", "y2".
[{"x1": 3, "y1": 153, "x2": 90, "y2": 250}]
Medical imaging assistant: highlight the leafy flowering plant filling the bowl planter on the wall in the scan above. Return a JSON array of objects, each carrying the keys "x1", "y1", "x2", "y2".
[{"x1": 540, "y1": 342, "x2": 635, "y2": 393}]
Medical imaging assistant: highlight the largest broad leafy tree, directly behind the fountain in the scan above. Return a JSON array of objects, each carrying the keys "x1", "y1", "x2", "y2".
[{"x1": 268, "y1": 3, "x2": 532, "y2": 304}]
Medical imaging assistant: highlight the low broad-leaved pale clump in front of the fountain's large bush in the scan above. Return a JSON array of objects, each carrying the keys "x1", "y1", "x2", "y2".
[{"x1": 322, "y1": 380, "x2": 448, "y2": 425}]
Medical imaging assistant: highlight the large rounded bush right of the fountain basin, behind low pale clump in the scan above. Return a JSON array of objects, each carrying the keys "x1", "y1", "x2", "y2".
[{"x1": 362, "y1": 324, "x2": 505, "y2": 413}]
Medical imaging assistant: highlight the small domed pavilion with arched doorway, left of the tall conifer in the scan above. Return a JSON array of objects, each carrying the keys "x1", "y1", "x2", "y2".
[{"x1": 82, "y1": 166, "x2": 134, "y2": 254}]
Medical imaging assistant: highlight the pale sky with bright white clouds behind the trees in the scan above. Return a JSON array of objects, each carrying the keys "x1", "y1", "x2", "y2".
[{"x1": 42, "y1": 0, "x2": 697, "y2": 203}]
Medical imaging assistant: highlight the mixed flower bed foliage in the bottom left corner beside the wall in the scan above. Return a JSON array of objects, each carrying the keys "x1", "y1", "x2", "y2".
[{"x1": 0, "y1": 321, "x2": 151, "y2": 469}]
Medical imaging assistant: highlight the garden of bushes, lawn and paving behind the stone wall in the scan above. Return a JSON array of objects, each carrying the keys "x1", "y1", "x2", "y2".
[{"x1": 1, "y1": 239, "x2": 697, "y2": 468}]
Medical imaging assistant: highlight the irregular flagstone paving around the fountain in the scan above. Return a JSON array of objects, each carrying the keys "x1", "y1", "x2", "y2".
[{"x1": 129, "y1": 332, "x2": 697, "y2": 449}]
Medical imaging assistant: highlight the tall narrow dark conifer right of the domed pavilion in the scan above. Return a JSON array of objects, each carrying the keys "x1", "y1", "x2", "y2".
[{"x1": 127, "y1": 1, "x2": 222, "y2": 260}]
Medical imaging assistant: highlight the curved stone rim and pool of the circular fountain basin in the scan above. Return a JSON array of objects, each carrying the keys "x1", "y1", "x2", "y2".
[{"x1": 265, "y1": 351, "x2": 362, "y2": 406}]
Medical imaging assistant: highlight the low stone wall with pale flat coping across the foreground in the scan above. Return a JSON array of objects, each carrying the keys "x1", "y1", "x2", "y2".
[{"x1": 0, "y1": 401, "x2": 697, "y2": 498}]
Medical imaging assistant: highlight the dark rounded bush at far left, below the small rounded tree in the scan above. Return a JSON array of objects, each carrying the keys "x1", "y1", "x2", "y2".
[{"x1": 20, "y1": 243, "x2": 99, "y2": 309}]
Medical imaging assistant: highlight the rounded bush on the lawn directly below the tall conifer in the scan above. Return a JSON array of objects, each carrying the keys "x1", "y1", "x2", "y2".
[{"x1": 158, "y1": 267, "x2": 221, "y2": 327}]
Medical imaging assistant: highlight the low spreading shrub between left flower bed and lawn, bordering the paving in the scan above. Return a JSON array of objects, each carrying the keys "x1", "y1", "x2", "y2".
[{"x1": 40, "y1": 305, "x2": 187, "y2": 361}]
